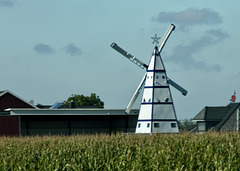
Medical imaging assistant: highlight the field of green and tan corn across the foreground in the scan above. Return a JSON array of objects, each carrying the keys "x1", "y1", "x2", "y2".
[{"x1": 0, "y1": 133, "x2": 240, "y2": 170}]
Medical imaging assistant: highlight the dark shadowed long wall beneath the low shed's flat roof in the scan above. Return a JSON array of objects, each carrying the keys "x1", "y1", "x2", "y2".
[{"x1": 21, "y1": 115, "x2": 138, "y2": 136}]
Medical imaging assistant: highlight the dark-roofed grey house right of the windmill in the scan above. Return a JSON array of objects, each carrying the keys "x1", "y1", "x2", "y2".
[{"x1": 193, "y1": 103, "x2": 240, "y2": 132}]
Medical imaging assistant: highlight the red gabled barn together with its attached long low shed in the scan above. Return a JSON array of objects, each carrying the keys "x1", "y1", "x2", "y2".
[{"x1": 0, "y1": 91, "x2": 139, "y2": 136}]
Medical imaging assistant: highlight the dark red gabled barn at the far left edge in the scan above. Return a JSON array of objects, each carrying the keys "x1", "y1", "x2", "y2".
[{"x1": 0, "y1": 90, "x2": 37, "y2": 136}]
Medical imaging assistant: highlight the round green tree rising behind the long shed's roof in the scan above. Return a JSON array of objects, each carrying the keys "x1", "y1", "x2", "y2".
[{"x1": 62, "y1": 93, "x2": 104, "y2": 108}]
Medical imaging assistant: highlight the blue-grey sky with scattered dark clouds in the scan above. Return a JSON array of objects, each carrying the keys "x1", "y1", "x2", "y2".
[{"x1": 0, "y1": 0, "x2": 240, "y2": 119}]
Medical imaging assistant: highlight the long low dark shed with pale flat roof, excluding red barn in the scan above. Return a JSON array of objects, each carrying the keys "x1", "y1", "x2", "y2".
[{"x1": 7, "y1": 109, "x2": 139, "y2": 136}]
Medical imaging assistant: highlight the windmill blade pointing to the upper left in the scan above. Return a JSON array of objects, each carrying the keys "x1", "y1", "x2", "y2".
[{"x1": 111, "y1": 43, "x2": 148, "y2": 69}]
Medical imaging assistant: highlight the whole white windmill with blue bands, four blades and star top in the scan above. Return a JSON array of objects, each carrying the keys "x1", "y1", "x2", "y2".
[{"x1": 111, "y1": 24, "x2": 187, "y2": 133}]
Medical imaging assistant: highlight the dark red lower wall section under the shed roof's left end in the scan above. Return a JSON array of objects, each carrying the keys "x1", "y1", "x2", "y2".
[{"x1": 0, "y1": 116, "x2": 19, "y2": 136}]
